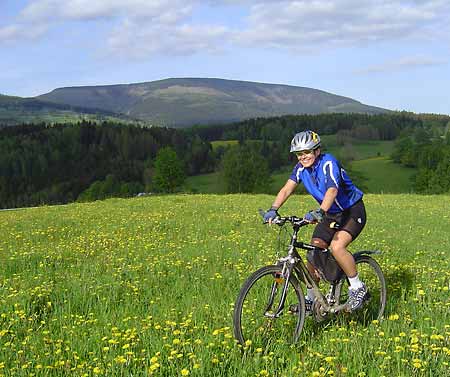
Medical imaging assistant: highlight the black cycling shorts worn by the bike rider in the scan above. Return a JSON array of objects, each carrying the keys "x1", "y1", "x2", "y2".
[{"x1": 312, "y1": 199, "x2": 366, "y2": 245}]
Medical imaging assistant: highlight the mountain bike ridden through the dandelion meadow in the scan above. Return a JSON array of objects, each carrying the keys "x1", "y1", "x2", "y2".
[{"x1": 233, "y1": 211, "x2": 386, "y2": 347}]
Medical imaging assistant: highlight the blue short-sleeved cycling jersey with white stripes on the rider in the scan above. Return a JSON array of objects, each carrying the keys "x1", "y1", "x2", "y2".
[{"x1": 289, "y1": 153, "x2": 363, "y2": 213}]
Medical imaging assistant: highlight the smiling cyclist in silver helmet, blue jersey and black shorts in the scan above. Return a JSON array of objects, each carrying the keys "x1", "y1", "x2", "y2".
[{"x1": 264, "y1": 130, "x2": 367, "y2": 312}]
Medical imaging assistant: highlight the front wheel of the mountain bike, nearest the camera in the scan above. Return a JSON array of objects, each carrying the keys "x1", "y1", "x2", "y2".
[{"x1": 233, "y1": 266, "x2": 305, "y2": 347}]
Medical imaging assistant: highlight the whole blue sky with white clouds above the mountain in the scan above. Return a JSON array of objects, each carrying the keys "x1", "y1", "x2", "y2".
[{"x1": 0, "y1": 0, "x2": 450, "y2": 114}]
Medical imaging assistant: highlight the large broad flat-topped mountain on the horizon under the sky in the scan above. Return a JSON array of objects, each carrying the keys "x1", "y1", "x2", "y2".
[{"x1": 37, "y1": 78, "x2": 388, "y2": 127}]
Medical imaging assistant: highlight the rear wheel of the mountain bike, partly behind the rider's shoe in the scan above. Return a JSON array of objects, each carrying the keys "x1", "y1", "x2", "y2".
[{"x1": 339, "y1": 255, "x2": 387, "y2": 323}]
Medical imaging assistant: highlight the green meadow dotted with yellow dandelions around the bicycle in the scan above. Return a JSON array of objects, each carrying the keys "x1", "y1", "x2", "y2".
[{"x1": 0, "y1": 195, "x2": 450, "y2": 377}]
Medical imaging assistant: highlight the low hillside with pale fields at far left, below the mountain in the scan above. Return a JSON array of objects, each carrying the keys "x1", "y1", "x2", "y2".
[{"x1": 0, "y1": 94, "x2": 138, "y2": 126}]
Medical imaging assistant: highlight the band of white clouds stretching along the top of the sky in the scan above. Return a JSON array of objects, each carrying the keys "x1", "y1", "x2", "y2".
[{"x1": 0, "y1": 0, "x2": 450, "y2": 57}]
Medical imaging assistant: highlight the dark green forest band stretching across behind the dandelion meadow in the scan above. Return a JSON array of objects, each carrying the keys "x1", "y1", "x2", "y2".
[{"x1": 0, "y1": 112, "x2": 450, "y2": 208}]
